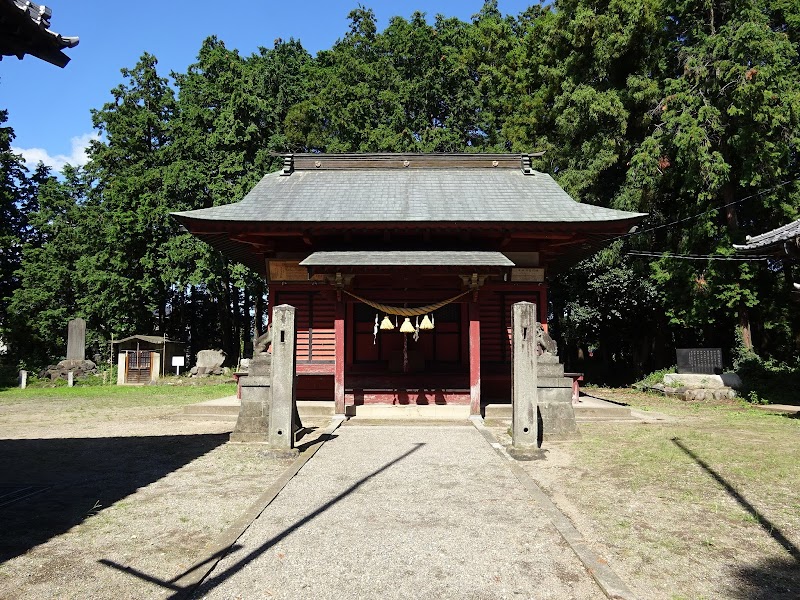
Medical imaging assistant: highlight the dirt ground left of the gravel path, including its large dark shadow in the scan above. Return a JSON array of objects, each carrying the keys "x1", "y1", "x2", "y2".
[{"x1": 0, "y1": 400, "x2": 322, "y2": 599}]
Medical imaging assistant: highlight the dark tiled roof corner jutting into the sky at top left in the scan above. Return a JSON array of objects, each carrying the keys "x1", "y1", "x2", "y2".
[{"x1": 0, "y1": 0, "x2": 79, "y2": 67}]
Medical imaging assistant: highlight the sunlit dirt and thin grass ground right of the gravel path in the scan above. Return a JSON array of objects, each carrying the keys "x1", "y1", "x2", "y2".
[{"x1": 492, "y1": 390, "x2": 800, "y2": 600}]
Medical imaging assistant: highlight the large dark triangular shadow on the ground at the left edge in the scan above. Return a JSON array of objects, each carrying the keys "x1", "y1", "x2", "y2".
[{"x1": 0, "y1": 433, "x2": 229, "y2": 562}]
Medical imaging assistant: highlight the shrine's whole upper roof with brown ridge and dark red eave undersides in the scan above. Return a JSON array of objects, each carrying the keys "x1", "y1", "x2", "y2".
[{"x1": 172, "y1": 153, "x2": 646, "y2": 274}]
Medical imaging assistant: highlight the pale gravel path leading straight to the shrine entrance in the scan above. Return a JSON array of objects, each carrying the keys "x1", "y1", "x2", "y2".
[{"x1": 196, "y1": 425, "x2": 604, "y2": 600}]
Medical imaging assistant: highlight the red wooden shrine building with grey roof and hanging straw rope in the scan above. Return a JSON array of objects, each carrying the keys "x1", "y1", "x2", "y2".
[{"x1": 174, "y1": 154, "x2": 644, "y2": 414}]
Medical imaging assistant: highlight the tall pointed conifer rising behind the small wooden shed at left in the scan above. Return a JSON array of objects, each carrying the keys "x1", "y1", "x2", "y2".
[{"x1": 84, "y1": 53, "x2": 177, "y2": 334}]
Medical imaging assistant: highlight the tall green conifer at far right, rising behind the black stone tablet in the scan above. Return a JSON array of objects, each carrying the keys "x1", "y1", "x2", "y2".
[{"x1": 628, "y1": 0, "x2": 800, "y2": 356}]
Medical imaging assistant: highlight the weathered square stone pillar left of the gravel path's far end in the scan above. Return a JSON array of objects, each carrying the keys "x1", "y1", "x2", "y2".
[{"x1": 269, "y1": 304, "x2": 297, "y2": 450}]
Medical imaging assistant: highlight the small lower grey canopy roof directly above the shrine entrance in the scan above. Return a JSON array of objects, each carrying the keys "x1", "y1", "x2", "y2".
[{"x1": 300, "y1": 251, "x2": 514, "y2": 267}]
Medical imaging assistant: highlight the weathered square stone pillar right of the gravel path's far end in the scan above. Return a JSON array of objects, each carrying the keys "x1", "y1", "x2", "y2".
[{"x1": 509, "y1": 302, "x2": 541, "y2": 460}]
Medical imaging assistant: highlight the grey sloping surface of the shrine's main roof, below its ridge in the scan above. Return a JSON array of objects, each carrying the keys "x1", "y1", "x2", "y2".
[{"x1": 173, "y1": 155, "x2": 644, "y2": 223}]
